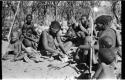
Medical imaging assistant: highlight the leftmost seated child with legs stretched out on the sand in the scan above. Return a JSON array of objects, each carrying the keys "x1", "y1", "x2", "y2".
[{"x1": 3, "y1": 31, "x2": 42, "y2": 61}]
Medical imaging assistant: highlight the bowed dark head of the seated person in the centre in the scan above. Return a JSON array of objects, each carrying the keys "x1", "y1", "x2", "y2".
[{"x1": 50, "y1": 21, "x2": 61, "y2": 34}]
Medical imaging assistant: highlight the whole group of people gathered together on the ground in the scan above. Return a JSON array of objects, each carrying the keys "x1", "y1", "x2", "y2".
[{"x1": 3, "y1": 14, "x2": 122, "y2": 79}]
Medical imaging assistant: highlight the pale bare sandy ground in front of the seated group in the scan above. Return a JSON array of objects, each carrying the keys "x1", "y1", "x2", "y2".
[{"x1": 2, "y1": 41, "x2": 78, "y2": 80}]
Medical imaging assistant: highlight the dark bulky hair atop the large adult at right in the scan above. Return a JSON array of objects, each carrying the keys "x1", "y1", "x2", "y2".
[{"x1": 95, "y1": 15, "x2": 112, "y2": 25}]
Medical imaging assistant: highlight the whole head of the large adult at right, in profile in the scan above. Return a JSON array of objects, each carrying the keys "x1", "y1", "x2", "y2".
[{"x1": 95, "y1": 15, "x2": 112, "y2": 31}]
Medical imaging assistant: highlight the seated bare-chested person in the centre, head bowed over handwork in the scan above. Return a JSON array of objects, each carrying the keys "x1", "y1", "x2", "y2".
[{"x1": 38, "y1": 21, "x2": 72, "y2": 61}]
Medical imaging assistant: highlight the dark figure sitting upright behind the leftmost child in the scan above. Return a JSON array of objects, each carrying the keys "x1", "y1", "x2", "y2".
[{"x1": 22, "y1": 14, "x2": 38, "y2": 49}]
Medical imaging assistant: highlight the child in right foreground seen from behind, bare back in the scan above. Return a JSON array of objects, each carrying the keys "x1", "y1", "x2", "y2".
[{"x1": 93, "y1": 48, "x2": 116, "y2": 79}]
